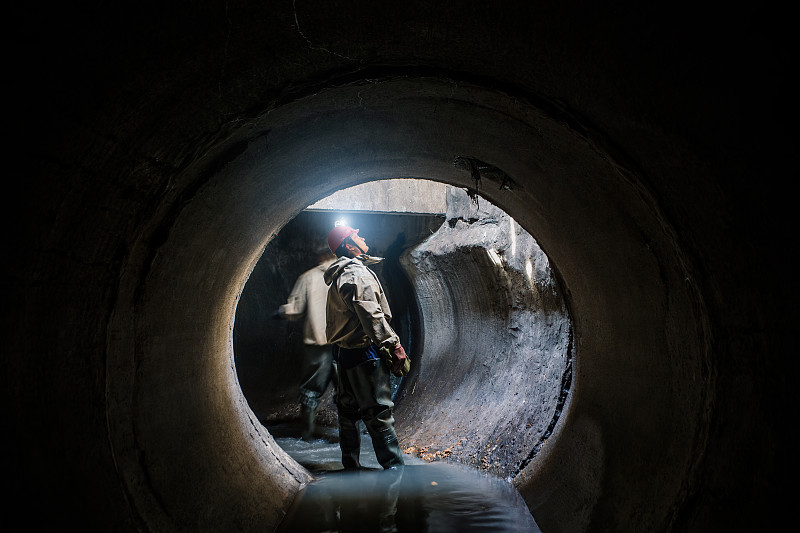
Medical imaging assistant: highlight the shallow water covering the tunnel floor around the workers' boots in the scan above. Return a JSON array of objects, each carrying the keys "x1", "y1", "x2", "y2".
[{"x1": 267, "y1": 425, "x2": 540, "y2": 533}]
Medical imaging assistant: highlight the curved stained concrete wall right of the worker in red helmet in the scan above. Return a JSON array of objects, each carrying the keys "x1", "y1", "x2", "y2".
[{"x1": 397, "y1": 187, "x2": 574, "y2": 481}]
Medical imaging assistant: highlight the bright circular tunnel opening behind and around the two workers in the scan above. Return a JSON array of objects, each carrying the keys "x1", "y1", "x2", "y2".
[{"x1": 233, "y1": 179, "x2": 574, "y2": 480}]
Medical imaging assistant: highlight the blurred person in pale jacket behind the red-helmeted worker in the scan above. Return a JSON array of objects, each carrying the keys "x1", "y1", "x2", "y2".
[{"x1": 278, "y1": 249, "x2": 336, "y2": 441}]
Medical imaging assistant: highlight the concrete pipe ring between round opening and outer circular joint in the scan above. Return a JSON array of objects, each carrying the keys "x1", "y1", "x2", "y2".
[{"x1": 107, "y1": 78, "x2": 713, "y2": 530}]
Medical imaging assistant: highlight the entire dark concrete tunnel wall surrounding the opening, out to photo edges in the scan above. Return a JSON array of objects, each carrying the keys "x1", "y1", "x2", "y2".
[{"x1": 4, "y1": 2, "x2": 797, "y2": 531}]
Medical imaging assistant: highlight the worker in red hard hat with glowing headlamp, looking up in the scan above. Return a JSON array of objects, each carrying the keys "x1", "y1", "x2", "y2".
[{"x1": 324, "y1": 226, "x2": 410, "y2": 470}]
